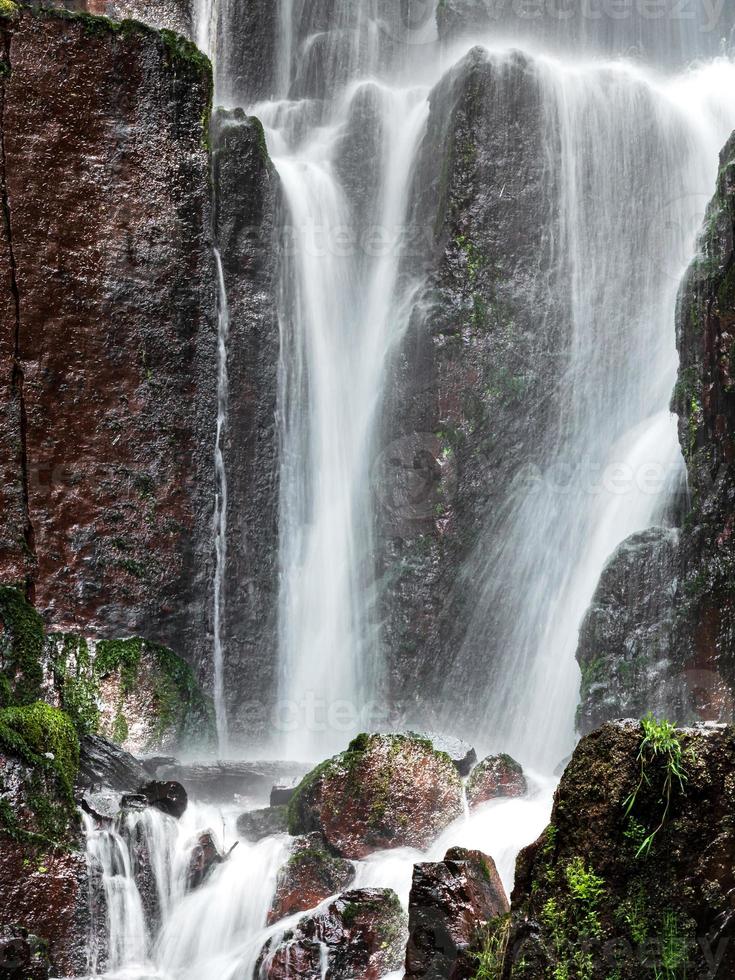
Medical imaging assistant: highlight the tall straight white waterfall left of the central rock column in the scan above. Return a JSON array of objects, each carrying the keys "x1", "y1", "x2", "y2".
[{"x1": 253, "y1": 3, "x2": 440, "y2": 757}]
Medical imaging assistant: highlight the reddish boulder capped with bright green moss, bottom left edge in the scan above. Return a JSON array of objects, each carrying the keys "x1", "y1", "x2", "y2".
[{"x1": 0, "y1": 702, "x2": 89, "y2": 978}]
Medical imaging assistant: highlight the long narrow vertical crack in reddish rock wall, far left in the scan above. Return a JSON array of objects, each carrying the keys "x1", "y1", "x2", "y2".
[{"x1": 0, "y1": 30, "x2": 36, "y2": 600}]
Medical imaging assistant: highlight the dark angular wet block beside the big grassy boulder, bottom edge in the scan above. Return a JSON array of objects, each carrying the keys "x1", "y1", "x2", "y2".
[{"x1": 405, "y1": 847, "x2": 510, "y2": 980}]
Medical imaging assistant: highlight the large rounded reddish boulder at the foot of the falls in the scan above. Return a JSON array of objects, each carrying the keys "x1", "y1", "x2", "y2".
[{"x1": 288, "y1": 735, "x2": 462, "y2": 859}]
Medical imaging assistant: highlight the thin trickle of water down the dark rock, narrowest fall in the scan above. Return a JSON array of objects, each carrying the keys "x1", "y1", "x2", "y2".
[{"x1": 213, "y1": 249, "x2": 230, "y2": 754}]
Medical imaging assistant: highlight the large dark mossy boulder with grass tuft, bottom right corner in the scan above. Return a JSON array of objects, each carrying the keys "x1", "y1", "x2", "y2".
[{"x1": 502, "y1": 722, "x2": 735, "y2": 980}]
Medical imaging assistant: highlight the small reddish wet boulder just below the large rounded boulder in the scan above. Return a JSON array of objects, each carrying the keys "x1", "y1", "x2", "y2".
[{"x1": 268, "y1": 834, "x2": 355, "y2": 925}]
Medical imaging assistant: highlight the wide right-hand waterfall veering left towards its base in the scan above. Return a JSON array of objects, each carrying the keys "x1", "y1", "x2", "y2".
[{"x1": 440, "y1": 57, "x2": 735, "y2": 771}]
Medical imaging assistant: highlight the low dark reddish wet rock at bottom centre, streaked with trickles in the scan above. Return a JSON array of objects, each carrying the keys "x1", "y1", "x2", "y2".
[{"x1": 256, "y1": 888, "x2": 406, "y2": 980}]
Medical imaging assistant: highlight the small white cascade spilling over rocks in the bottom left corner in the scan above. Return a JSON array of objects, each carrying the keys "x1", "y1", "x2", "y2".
[{"x1": 84, "y1": 803, "x2": 288, "y2": 980}]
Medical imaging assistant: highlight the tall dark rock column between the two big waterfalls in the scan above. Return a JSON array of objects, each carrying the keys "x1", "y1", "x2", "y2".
[{"x1": 379, "y1": 49, "x2": 570, "y2": 739}]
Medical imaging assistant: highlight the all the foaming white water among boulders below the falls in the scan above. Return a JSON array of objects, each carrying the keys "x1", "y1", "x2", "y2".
[{"x1": 77, "y1": 788, "x2": 554, "y2": 980}]
